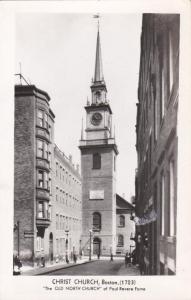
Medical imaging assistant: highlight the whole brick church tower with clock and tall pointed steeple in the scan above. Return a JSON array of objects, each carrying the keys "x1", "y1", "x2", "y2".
[{"x1": 79, "y1": 29, "x2": 118, "y2": 255}]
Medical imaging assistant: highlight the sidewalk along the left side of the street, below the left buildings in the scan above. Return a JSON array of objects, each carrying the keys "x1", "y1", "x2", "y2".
[{"x1": 21, "y1": 257, "x2": 95, "y2": 276}]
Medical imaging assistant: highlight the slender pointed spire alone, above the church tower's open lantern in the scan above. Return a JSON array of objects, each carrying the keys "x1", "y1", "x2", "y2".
[{"x1": 94, "y1": 28, "x2": 103, "y2": 82}]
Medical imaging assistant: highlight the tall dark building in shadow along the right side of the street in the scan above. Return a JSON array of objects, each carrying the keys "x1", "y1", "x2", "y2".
[{"x1": 136, "y1": 14, "x2": 179, "y2": 274}]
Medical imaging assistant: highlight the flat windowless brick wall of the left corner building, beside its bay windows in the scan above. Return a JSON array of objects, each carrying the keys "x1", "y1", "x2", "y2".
[{"x1": 14, "y1": 96, "x2": 35, "y2": 260}]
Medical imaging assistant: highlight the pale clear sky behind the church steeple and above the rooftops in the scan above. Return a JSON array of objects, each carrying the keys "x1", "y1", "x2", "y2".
[{"x1": 15, "y1": 13, "x2": 142, "y2": 200}]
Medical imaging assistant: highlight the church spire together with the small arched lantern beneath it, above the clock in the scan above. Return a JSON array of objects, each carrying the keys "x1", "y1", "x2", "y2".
[{"x1": 91, "y1": 27, "x2": 107, "y2": 105}]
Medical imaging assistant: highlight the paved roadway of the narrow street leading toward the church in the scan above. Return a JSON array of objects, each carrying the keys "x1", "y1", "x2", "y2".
[{"x1": 43, "y1": 259, "x2": 140, "y2": 276}]
